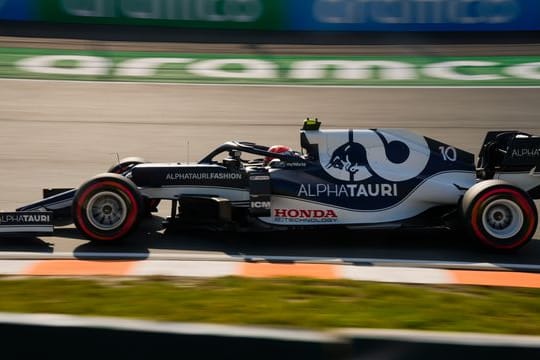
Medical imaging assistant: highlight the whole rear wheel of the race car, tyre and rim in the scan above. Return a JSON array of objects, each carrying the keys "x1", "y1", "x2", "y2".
[{"x1": 461, "y1": 180, "x2": 538, "y2": 251}]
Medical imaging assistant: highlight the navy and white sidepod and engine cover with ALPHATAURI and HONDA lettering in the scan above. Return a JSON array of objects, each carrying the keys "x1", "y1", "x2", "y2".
[{"x1": 261, "y1": 129, "x2": 476, "y2": 225}]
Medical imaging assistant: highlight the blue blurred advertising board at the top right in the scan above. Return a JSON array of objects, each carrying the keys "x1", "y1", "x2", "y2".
[{"x1": 290, "y1": 0, "x2": 540, "y2": 31}]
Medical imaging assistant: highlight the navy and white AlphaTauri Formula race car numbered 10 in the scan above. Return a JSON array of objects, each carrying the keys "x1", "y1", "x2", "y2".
[{"x1": 0, "y1": 119, "x2": 540, "y2": 250}]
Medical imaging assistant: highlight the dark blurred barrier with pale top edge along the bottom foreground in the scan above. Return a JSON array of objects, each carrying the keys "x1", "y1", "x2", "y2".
[{"x1": 0, "y1": 313, "x2": 540, "y2": 359}]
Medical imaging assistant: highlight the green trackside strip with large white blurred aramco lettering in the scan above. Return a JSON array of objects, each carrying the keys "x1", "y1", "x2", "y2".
[{"x1": 0, "y1": 48, "x2": 540, "y2": 87}]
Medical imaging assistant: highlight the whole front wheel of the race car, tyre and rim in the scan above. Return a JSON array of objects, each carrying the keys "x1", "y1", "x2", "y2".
[{"x1": 72, "y1": 173, "x2": 143, "y2": 241}]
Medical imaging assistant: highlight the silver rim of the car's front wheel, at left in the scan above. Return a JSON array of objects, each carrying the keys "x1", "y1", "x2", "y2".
[{"x1": 86, "y1": 191, "x2": 127, "y2": 231}]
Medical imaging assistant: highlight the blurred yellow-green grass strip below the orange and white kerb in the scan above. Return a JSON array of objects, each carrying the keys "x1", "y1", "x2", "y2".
[{"x1": 0, "y1": 277, "x2": 540, "y2": 335}]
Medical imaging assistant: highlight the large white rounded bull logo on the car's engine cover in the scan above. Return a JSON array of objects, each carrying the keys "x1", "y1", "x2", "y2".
[{"x1": 306, "y1": 130, "x2": 430, "y2": 182}]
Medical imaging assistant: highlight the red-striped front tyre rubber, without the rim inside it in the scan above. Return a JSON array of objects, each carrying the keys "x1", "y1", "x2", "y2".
[{"x1": 72, "y1": 174, "x2": 142, "y2": 241}]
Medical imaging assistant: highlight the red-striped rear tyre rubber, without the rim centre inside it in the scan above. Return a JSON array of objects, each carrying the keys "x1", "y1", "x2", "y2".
[{"x1": 463, "y1": 181, "x2": 538, "y2": 251}]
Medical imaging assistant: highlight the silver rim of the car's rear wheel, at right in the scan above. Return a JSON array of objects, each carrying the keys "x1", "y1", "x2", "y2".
[{"x1": 482, "y1": 199, "x2": 524, "y2": 239}]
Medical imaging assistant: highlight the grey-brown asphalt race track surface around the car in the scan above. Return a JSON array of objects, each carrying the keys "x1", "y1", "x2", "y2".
[{"x1": 0, "y1": 80, "x2": 540, "y2": 265}]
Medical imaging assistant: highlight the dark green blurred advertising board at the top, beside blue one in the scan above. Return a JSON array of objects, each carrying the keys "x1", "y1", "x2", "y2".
[{"x1": 37, "y1": 0, "x2": 286, "y2": 30}]
